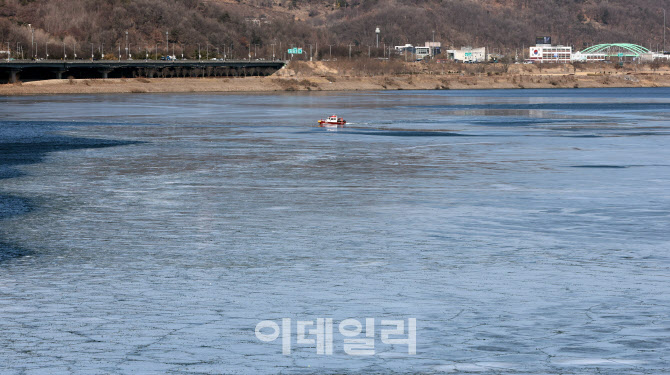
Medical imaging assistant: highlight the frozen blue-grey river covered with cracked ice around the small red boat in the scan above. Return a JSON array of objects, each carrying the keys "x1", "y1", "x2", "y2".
[{"x1": 0, "y1": 89, "x2": 670, "y2": 375}]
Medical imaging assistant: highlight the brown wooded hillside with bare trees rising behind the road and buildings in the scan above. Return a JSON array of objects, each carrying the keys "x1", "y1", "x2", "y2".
[{"x1": 0, "y1": 0, "x2": 670, "y2": 58}]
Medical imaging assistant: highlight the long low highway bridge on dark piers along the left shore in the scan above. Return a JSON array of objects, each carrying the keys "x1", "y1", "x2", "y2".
[{"x1": 0, "y1": 60, "x2": 286, "y2": 83}]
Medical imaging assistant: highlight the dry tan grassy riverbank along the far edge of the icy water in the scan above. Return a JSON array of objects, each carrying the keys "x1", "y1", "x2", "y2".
[{"x1": 0, "y1": 62, "x2": 670, "y2": 95}]
